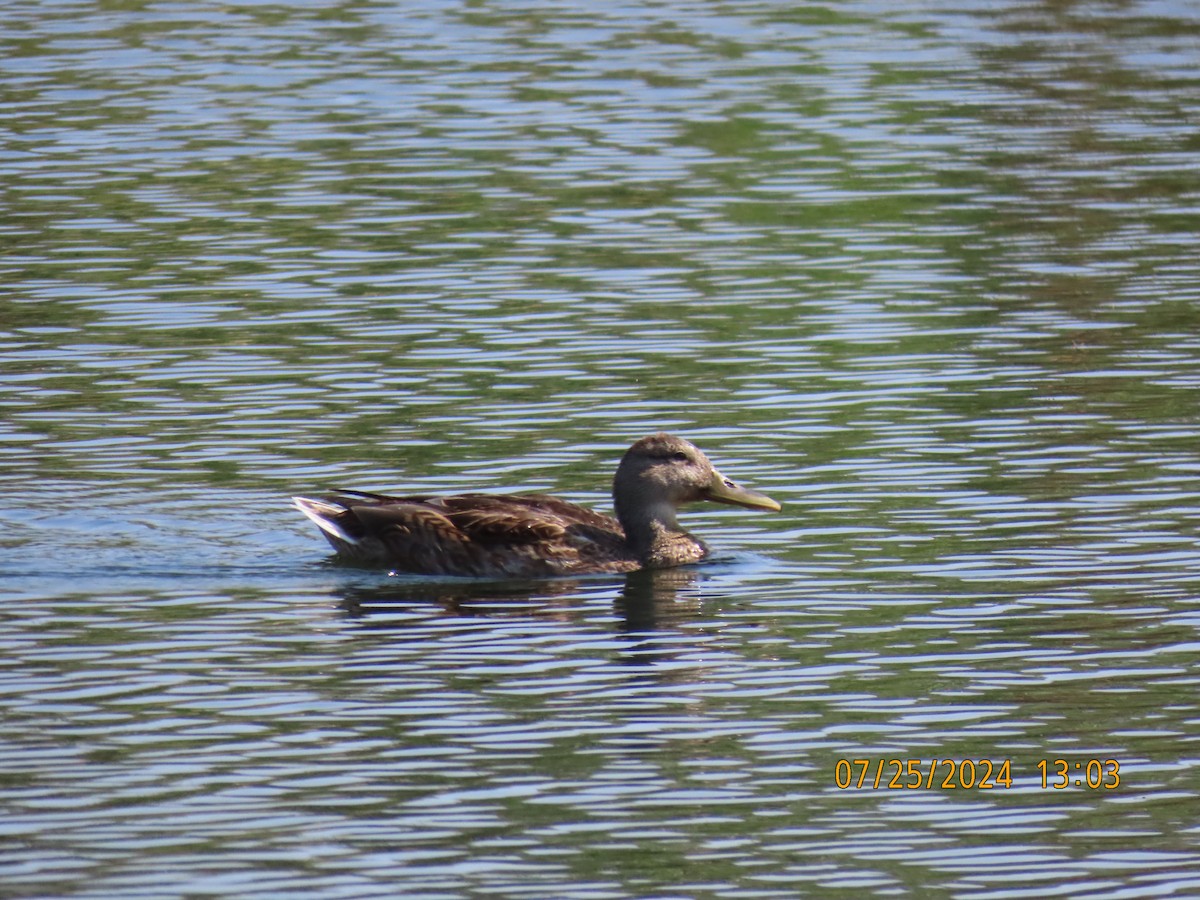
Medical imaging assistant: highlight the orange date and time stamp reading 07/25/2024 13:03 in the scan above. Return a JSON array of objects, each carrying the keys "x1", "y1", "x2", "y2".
[{"x1": 833, "y1": 757, "x2": 1121, "y2": 791}]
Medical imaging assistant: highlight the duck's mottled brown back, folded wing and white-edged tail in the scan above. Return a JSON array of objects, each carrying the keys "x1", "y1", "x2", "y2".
[{"x1": 294, "y1": 491, "x2": 638, "y2": 577}]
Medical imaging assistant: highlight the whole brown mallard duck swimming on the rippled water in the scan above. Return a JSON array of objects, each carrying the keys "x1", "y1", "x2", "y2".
[{"x1": 293, "y1": 433, "x2": 780, "y2": 578}]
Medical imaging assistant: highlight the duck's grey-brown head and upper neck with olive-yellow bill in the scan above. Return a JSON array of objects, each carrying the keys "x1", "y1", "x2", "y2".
[{"x1": 612, "y1": 432, "x2": 780, "y2": 532}]
